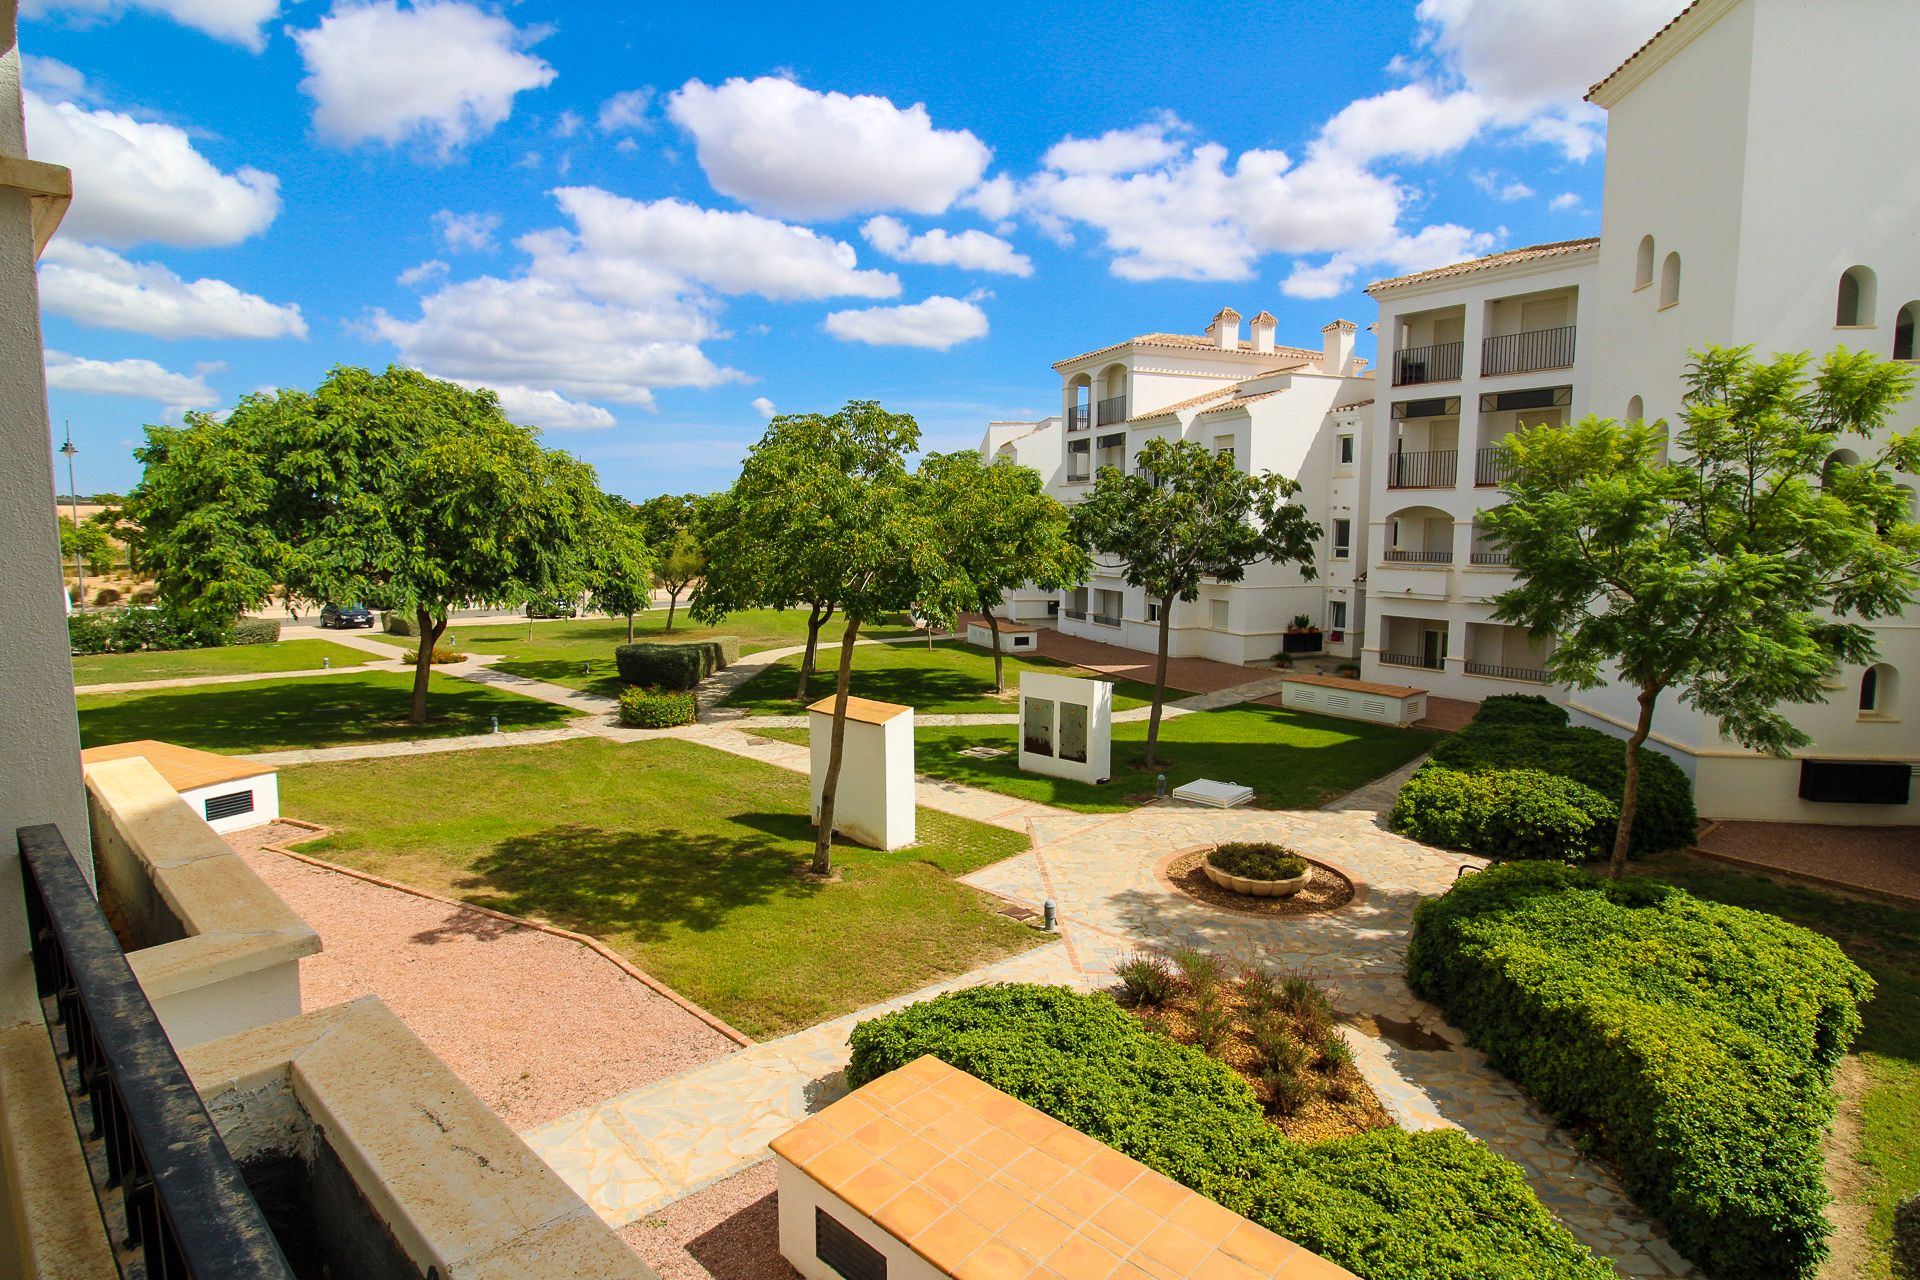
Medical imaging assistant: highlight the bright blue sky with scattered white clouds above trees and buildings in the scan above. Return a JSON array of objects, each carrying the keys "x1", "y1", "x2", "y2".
[{"x1": 19, "y1": 0, "x2": 1678, "y2": 499}]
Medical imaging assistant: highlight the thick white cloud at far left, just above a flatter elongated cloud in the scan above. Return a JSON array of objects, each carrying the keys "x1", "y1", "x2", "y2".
[{"x1": 25, "y1": 92, "x2": 280, "y2": 248}]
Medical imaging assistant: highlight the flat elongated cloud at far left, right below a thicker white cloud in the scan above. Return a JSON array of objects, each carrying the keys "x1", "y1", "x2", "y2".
[{"x1": 40, "y1": 240, "x2": 307, "y2": 338}]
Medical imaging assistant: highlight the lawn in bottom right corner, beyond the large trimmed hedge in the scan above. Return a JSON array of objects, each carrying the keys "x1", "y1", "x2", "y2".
[{"x1": 1634, "y1": 854, "x2": 1920, "y2": 1280}]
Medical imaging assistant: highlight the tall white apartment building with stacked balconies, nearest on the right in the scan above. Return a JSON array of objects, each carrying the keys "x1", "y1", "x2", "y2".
[{"x1": 1363, "y1": 0, "x2": 1920, "y2": 823}]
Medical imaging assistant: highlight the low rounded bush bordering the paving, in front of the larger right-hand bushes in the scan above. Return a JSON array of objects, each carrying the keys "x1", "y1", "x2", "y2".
[{"x1": 1390, "y1": 764, "x2": 1620, "y2": 862}]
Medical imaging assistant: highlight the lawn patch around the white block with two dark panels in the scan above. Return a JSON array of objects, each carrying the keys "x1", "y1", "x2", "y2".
[{"x1": 749, "y1": 706, "x2": 1440, "y2": 814}]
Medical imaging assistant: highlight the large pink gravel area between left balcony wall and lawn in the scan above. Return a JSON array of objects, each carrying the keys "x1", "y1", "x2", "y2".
[{"x1": 228, "y1": 823, "x2": 739, "y2": 1130}]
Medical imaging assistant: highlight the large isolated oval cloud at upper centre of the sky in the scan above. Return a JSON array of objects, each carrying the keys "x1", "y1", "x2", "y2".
[{"x1": 666, "y1": 77, "x2": 993, "y2": 221}]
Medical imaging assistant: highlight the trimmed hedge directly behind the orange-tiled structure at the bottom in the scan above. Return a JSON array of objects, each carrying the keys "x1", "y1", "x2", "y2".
[{"x1": 847, "y1": 984, "x2": 1615, "y2": 1280}]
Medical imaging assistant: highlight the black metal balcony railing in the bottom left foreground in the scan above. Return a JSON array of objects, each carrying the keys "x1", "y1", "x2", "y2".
[{"x1": 15, "y1": 825, "x2": 294, "y2": 1280}]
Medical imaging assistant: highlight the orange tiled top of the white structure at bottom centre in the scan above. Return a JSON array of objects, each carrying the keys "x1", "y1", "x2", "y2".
[{"x1": 772, "y1": 1055, "x2": 1352, "y2": 1280}]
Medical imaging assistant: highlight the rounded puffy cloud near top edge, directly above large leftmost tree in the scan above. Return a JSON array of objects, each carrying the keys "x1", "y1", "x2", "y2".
[{"x1": 292, "y1": 0, "x2": 555, "y2": 155}]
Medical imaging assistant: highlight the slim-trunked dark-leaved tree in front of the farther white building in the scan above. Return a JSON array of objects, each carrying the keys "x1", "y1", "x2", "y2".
[{"x1": 1073, "y1": 438, "x2": 1321, "y2": 768}]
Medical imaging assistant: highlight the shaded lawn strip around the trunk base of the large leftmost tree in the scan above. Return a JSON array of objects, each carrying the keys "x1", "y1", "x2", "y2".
[{"x1": 79, "y1": 672, "x2": 572, "y2": 760}]
